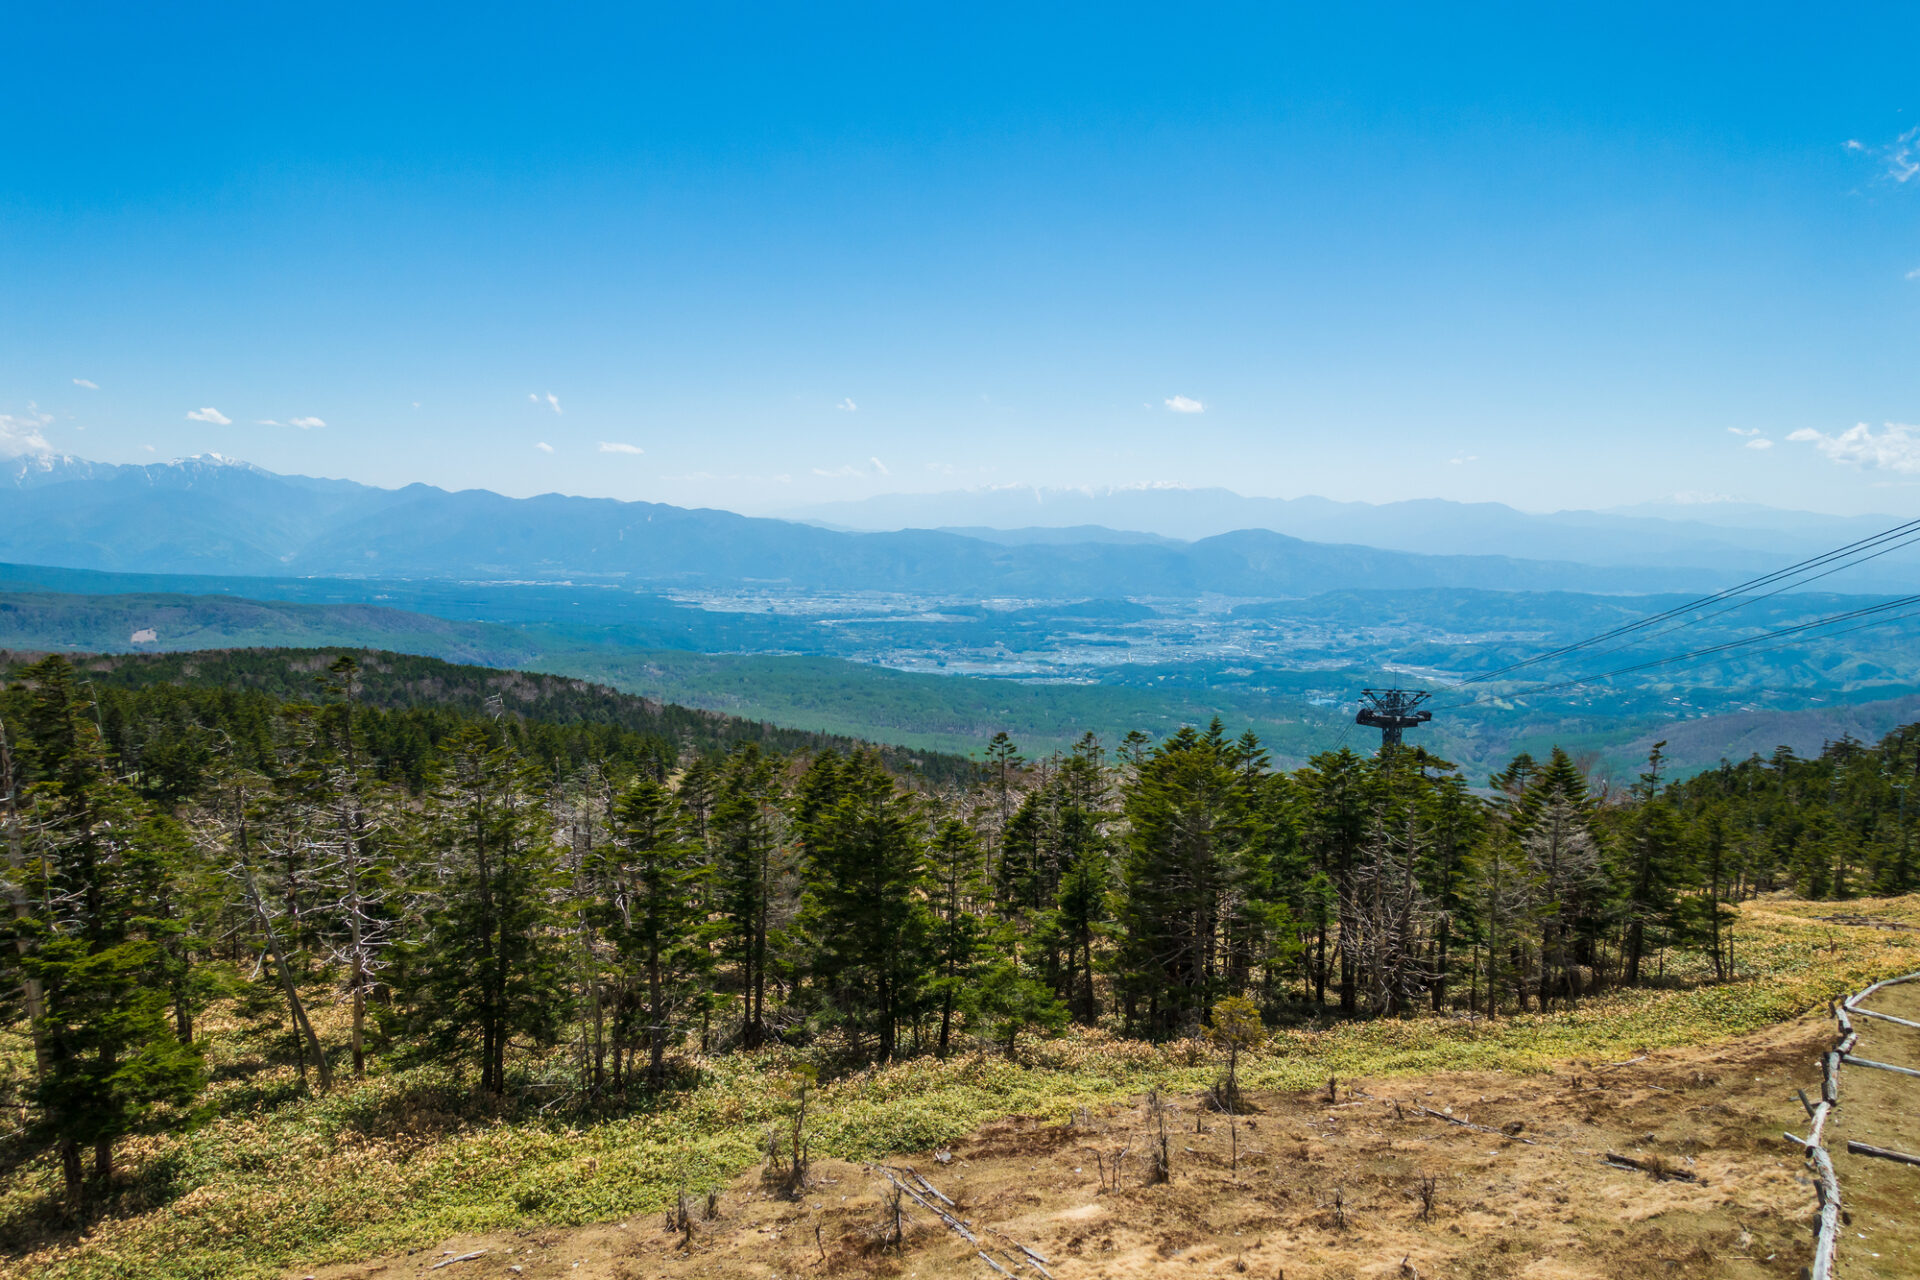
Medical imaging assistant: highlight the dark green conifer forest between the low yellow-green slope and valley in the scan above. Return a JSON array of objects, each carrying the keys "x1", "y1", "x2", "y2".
[{"x1": 0, "y1": 654, "x2": 1920, "y2": 1215}]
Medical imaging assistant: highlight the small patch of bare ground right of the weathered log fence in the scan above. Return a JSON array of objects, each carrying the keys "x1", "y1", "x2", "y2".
[{"x1": 1801, "y1": 983, "x2": 1920, "y2": 1280}]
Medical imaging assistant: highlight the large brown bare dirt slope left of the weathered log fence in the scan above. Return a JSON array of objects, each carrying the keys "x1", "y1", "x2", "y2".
[{"x1": 290, "y1": 1013, "x2": 1873, "y2": 1280}]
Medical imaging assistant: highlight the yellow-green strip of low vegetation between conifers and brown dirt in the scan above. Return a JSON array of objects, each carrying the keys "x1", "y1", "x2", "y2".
[{"x1": 0, "y1": 896, "x2": 1920, "y2": 1278}]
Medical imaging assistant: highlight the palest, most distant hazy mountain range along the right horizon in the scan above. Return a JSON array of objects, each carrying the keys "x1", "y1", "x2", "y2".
[{"x1": 783, "y1": 486, "x2": 1920, "y2": 591}]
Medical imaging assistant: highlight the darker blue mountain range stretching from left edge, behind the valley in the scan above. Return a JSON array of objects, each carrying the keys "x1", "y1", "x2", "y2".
[{"x1": 0, "y1": 455, "x2": 1827, "y2": 599}]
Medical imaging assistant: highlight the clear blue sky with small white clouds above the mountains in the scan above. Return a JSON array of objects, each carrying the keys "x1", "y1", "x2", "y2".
[{"x1": 0, "y1": 4, "x2": 1920, "y2": 514}]
